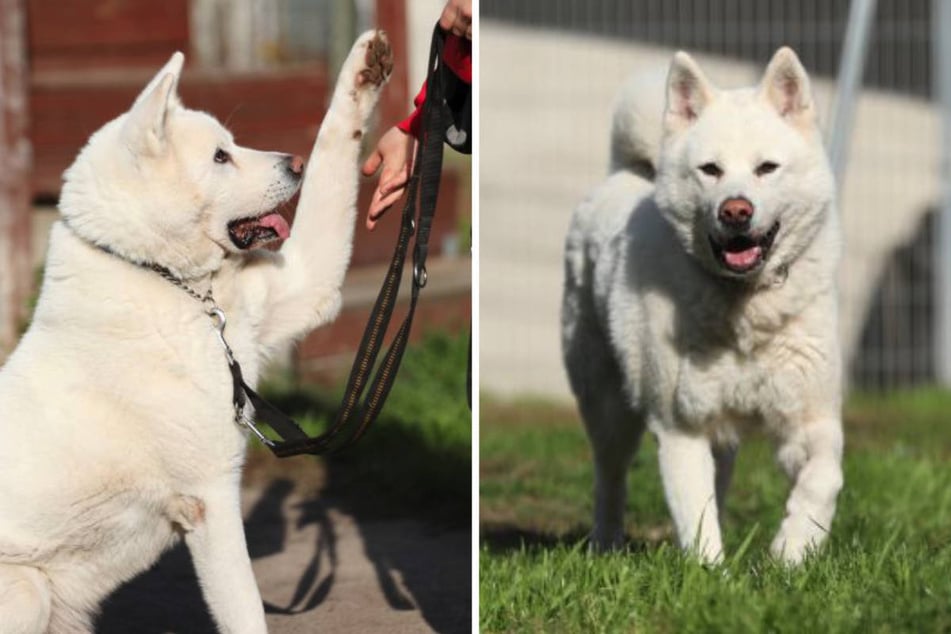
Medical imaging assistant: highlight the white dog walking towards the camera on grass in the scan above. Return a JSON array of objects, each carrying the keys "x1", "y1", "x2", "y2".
[{"x1": 562, "y1": 48, "x2": 842, "y2": 562}]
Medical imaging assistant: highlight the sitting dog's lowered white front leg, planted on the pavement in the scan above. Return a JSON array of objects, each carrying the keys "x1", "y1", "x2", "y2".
[{"x1": 176, "y1": 486, "x2": 267, "y2": 634}]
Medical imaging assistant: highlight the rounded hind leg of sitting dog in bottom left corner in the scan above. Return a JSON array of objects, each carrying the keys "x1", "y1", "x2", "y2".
[{"x1": 0, "y1": 564, "x2": 51, "y2": 634}]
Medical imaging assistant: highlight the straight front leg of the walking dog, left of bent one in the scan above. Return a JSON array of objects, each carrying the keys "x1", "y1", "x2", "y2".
[{"x1": 651, "y1": 425, "x2": 723, "y2": 562}]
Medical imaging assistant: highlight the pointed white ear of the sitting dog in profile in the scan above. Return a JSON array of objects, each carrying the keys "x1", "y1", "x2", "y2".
[{"x1": 123, "y1": 53, "x2": 185, "y2": 155}]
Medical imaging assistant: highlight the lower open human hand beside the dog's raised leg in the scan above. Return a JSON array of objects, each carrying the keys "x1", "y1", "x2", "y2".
[{"x1": 363, "y1": 126, "x2": 416, "y2": 231}]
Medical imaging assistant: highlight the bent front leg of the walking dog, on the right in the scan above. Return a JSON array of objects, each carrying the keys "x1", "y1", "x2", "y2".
[{"x1": 771, "y1": 416, "x2": 843, "y2": 564}]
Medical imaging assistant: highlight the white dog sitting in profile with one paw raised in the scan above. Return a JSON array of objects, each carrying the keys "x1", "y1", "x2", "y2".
[{"x1": 0, "y1": 32, "x2": 392, "y2": 634}]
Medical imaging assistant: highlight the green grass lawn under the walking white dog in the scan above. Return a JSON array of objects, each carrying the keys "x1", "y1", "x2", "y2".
[{"x1": 479, "y1": 391, "x2": 951, "y2": 634}]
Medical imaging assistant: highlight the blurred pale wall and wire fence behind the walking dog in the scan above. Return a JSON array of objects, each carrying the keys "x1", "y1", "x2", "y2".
[{"x1": 480, "y1": 0, "x2": 951, "y2": 402}]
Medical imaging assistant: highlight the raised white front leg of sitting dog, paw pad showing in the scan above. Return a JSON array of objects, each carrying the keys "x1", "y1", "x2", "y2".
[{"x1": 253, "y1": 31, "x2": 393, "y2": 346}]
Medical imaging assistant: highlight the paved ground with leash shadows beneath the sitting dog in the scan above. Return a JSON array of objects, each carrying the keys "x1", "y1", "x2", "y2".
[{"x1": 96, "y1": 466, "x2": 472, "y2": 634}]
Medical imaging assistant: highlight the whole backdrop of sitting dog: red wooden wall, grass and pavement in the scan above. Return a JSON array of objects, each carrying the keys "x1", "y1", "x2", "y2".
[{"x1": 0, "y1": 0, "x2": 472, "y2": 634}]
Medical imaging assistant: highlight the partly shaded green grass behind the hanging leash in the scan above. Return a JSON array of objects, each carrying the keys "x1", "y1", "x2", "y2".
[{"x1": 254, "y1": 333, "x2": 472, "y2": 527}]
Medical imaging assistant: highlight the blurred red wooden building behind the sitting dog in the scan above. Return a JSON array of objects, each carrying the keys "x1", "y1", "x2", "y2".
[{"x1": 0, "y1": 0, "x2": 471, "y2": 382}]
